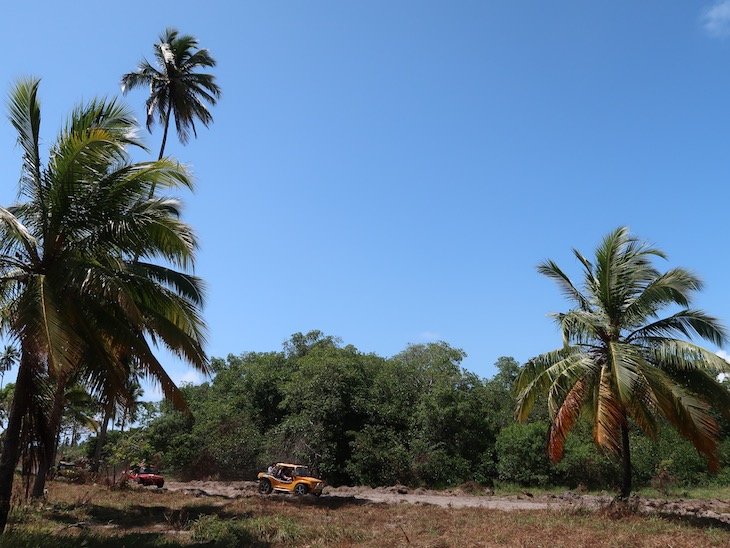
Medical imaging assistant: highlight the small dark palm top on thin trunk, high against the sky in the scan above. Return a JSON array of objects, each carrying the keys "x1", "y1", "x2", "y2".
[{"x1": 122, "y1": 28, "x2": 221, "y2": 159}]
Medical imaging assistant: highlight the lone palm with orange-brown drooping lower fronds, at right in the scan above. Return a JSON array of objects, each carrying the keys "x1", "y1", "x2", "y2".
[{"x1": 516, "y1": 228, "x2": 730, "y2": 498}]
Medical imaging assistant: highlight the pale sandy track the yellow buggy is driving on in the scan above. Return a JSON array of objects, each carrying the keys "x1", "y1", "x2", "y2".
[{"x1": 165, "y1": 481, "x2": 730, "y2": 526}]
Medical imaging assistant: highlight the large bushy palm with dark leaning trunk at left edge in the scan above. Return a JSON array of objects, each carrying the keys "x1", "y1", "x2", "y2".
[{"x1": 0, "y1": 80, "x2": 207, "y2": 531}]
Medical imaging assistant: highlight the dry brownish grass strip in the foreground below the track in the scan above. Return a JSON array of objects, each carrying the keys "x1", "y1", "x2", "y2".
[{"x1": 0, "y1": 482, "x2": 730, "y2": 548}]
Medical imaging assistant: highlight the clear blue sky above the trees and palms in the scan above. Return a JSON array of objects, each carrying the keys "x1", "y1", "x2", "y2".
[{"x1": 0, "y1": 0, "x2": 730, "y2": 392}]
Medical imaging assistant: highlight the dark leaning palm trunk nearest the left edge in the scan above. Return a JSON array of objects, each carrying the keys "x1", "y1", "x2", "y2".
[{"x1": 0, "y1": 350, "x2": 33, "y2": 533}]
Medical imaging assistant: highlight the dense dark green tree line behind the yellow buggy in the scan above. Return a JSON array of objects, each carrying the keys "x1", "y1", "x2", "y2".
[{"x1": 89, "y1": 331, "x2": 730, "y2": 488}]
